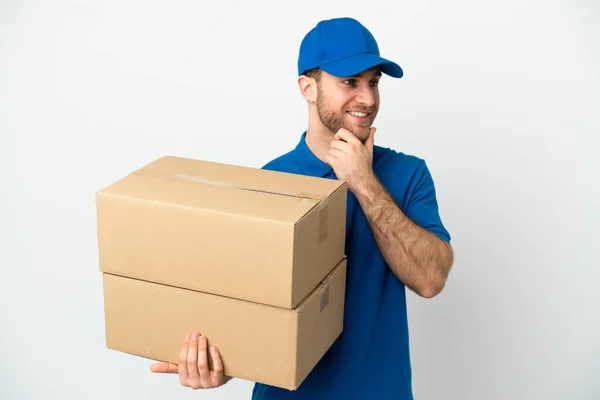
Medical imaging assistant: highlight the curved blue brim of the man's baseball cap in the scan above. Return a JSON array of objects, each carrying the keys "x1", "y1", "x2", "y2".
[{"x1": 320, "y1": 53, "x2": 404, "y2": 78}]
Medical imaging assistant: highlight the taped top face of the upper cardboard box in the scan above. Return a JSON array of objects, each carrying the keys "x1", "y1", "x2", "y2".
[{"x1": 98, "y1": 156, "x2": 345, "y2": 223}]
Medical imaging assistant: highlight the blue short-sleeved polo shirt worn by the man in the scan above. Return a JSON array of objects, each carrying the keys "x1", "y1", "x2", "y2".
[{"x1": 252, "y1": 132, "x2": 450, "y2": 400}]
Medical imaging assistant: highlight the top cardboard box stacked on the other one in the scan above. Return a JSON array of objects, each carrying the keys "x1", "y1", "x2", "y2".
[{"x1": 96, "y1": 156, "x2": 347, "y2": 309}]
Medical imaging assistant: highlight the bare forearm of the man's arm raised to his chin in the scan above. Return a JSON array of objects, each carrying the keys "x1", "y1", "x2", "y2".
[{"x1": 355, "y1": 176, "x2": 453, "y2": 298}]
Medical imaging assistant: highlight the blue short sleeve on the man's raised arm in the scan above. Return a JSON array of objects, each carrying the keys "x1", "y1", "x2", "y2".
[{"x1": 405, "y1": 161, "x2": 450, "y2": 242}]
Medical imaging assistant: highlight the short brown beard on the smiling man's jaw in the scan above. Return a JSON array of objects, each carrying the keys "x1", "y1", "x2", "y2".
[{"x1": 317, "y1": 87, "x2": 377, "y2": 143}]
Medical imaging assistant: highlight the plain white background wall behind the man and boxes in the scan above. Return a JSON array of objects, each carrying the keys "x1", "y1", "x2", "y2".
[{"x1": 0, "y1": 0, "x2": 600, "y2": 400}]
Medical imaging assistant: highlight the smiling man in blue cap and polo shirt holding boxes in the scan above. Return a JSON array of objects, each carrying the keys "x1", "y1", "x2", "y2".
[{"x1": 152, "y1": 18, "x2": 453, "y2": 400}]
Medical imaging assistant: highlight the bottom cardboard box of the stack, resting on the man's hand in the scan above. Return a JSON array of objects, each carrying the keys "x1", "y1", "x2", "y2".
[{"x1": 103, "y1": 259, "x2": 346, "y2": 390}]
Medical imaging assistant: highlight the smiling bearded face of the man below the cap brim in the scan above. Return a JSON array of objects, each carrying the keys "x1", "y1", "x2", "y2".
[{"x1": 316, "y1": 68, "x2": 381, "y2": 142}]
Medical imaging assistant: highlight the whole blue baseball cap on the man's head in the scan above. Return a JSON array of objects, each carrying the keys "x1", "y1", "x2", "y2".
[{"x1": 298, "y1": 18, "x2": 404, "y2": 78}]
